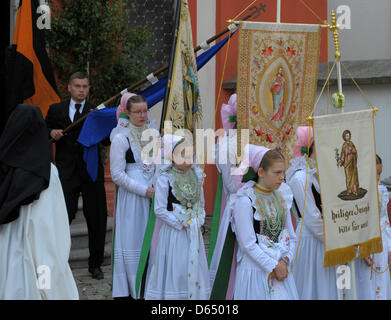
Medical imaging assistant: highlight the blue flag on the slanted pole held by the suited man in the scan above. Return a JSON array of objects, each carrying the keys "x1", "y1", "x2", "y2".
[{"x1": 78, "y1": 31, "x2": 236, "y2": 181}]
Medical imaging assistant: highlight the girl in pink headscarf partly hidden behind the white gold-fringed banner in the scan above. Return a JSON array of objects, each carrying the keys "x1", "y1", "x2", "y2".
[{"x1": 286, "y1": 127, "x2": 338, "y2": 300}]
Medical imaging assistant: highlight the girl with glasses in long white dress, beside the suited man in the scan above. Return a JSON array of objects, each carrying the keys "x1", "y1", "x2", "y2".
[{"x1": 110, "y1": 96, "x2": 155, "y2": 299}]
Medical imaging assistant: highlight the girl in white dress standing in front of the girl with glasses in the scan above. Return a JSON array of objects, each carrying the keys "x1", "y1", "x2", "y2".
[{"x1": 145, "y1": 134, "x2": 210, "y2": 300}]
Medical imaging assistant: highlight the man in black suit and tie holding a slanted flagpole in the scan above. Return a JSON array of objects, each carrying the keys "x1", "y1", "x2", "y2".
[{"x1": 45, "y1": 72, "x2": 107, "y2": 279}]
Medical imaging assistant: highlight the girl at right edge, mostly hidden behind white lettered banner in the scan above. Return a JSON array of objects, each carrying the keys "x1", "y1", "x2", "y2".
[{"x1": 355, "y1": 155, "x2": 391, "y2": 300}]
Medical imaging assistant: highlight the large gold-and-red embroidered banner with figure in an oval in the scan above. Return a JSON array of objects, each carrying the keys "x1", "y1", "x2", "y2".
[{"x1": 237, "y1": 22, "x2": 320, "y2": 163}]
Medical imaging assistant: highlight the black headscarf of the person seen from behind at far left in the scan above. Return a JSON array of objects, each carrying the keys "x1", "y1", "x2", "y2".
[{"x1": 0, "y1": 104, "x2": 50, "y2": 224}]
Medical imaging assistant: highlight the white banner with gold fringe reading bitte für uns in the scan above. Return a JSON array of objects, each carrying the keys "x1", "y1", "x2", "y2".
[{"x1": 314, "y1": 110, "x2": 382, "y2": 267}]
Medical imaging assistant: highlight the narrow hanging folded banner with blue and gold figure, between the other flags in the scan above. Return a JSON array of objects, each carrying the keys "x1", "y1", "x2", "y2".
[{"x1": 166, "y1": 0, "x2": 202, "y2": 132}]
